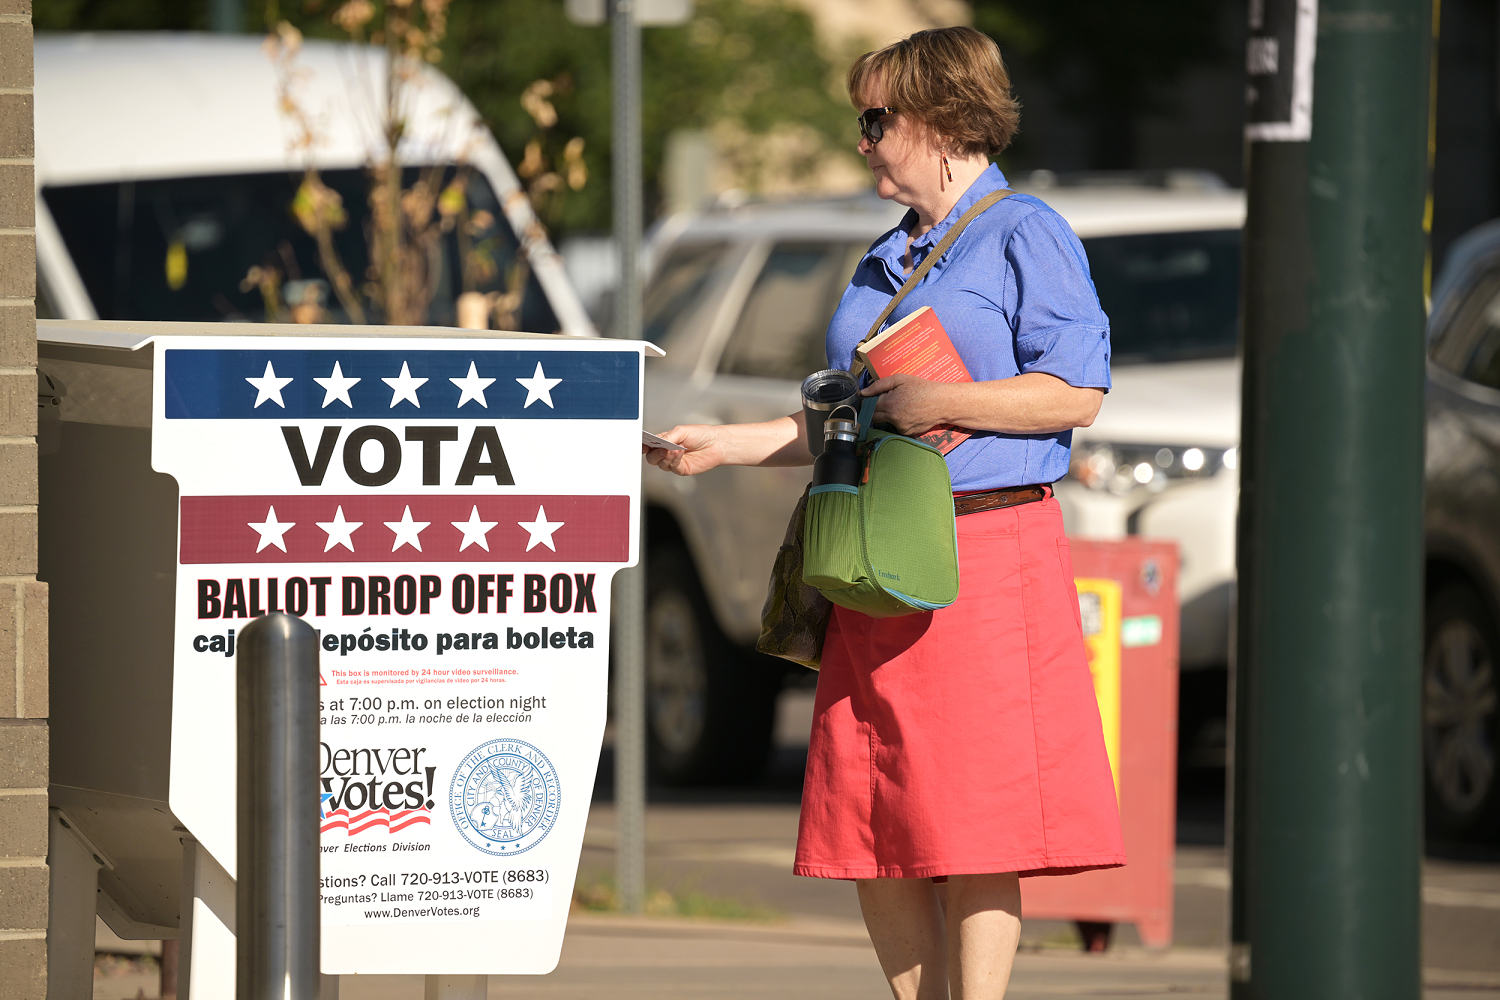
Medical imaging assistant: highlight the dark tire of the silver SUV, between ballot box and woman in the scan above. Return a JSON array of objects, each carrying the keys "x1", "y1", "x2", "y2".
[{"x1": 645, "y1": 546, "x2": 782, "y2": 786}]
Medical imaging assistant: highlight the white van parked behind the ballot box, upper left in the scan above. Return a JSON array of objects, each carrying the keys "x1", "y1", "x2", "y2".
[{"x1": 35, "y1": 34, "x2": 594, "y2": 336}]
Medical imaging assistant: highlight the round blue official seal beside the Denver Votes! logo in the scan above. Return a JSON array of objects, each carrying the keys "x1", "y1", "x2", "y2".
[{"x1": 449, "y1": 739, "x2": 561, "y2": 858}]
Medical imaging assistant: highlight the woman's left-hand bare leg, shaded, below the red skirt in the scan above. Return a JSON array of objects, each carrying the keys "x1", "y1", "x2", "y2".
[{"x1": 855, "y1": 879, "x2": 948, "y2": 1000}]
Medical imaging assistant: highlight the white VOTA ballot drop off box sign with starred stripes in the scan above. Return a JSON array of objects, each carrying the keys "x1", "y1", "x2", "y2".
[{"x1": 152, "y1": 337, "x2": 647, "y2": 975}]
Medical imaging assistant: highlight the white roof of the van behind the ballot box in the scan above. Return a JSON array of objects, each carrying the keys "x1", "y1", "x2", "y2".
[{"x1": 35, "y1": 33, "x2": 485, "y2": 187}]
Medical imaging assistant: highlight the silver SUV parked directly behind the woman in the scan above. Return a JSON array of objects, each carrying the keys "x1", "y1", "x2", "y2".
[{"x1": 644, "y1": 174, "x2": 1245, "y2": 781}]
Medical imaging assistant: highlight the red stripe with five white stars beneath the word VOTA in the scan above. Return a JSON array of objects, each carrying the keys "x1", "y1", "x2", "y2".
[{"x1": 179, "y1": 495, "x2": 630, "y2": 565}]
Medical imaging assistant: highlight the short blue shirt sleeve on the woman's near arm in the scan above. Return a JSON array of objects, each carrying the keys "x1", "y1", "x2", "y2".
[{"x1": 1005, "y1": 210, "x2": 1110, "y2": 390}]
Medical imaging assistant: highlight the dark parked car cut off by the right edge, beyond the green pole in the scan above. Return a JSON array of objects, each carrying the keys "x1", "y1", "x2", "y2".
[{"x1": 1422, "y1": 220, "x2": 1500, "y2": 843}]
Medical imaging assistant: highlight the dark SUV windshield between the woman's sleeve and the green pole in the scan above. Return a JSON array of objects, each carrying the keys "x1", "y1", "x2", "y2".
[{"x1": 1083, "y1": 229, "x2": 1241, "y2": 364}]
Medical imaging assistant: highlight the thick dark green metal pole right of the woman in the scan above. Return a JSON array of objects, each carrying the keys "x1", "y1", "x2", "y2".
[{"x1": 1230, "y1": 0, "x2": 1433, "y2": 1000}]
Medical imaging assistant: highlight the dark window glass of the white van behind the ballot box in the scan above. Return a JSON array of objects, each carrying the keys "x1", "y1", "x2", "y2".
[{"x1": 42, "y1": 166, "x2": 558, "y2": 333}]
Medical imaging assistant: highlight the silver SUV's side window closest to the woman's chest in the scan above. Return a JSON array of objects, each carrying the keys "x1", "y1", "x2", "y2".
[{"x1": 719, "y1": 241, "x2": 864, "y2": 381}]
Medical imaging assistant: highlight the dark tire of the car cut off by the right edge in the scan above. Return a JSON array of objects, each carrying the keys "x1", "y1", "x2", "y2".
[{"x1": 1422, "y1": 586, "x2": 1500, "y2": 843}]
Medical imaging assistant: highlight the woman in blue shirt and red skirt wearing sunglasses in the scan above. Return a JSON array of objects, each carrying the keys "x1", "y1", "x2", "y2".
[{"x1": 647, "y1": 27, "x2": 1125, "y2": 1000}]
